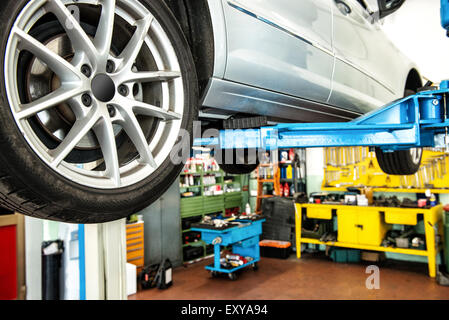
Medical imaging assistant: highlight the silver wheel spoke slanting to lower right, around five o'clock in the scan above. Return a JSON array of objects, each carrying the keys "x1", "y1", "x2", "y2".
[{"x1": 114, "y1": 108, "x2": 157, "y2": 169}]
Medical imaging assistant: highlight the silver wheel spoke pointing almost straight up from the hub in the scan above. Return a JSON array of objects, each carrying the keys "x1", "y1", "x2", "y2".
[{"x1": 94, "y1": 0, "x2": 115, "y2": 60}]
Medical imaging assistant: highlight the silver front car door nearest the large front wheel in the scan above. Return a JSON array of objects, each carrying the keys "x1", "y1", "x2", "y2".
[{"x1": 222, "y1": 0, "x2": 333, "y2": 102}]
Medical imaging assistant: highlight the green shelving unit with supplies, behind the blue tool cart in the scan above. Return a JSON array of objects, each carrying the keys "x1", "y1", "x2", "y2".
[{"x1": 180, "y1": 159, "x2": 248, "y2": 263}]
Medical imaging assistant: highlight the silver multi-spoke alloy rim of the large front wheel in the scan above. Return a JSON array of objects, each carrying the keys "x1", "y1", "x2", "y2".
[{"x1": 4, "y1": 0, "x2": 184, "y2": 189}]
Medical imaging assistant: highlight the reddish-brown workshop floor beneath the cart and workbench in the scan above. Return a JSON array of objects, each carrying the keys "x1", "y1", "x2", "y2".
[{"x1": 129, "y1": 254, "x2": 449, "y2": 300}]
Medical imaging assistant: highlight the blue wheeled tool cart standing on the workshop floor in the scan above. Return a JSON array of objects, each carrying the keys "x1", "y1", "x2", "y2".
[{"x1": 191, "y1": 217, "x2": 265, "y2": 280}]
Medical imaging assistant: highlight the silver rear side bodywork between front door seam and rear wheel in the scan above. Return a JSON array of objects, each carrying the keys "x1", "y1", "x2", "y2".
[{"x1": 329, "y1": 0, "x2": 405, "y2": 113}]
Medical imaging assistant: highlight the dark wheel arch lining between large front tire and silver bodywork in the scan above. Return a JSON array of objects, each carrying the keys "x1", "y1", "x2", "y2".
[{"x1": 164, "y1": 0, "x2": 215, "y2": 97}]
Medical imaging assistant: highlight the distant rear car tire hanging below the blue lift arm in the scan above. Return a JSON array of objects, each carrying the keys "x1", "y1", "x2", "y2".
[{"x1": 375, "y1": 89, "x2": 423, "y2": 175}]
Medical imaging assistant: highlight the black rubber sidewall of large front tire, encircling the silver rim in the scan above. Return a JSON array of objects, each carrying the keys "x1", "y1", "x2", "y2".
[{"x1": 0, "y1": 0, "x2": 198, "y2": 222}]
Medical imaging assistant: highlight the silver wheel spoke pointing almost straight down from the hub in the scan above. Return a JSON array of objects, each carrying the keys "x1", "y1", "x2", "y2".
[{"x1": 94, "y1": 114, "x2": 121, "y2": 187}]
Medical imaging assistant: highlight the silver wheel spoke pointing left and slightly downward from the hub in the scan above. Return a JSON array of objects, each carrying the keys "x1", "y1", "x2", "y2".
[{"x1": 16, "y1": 86, "x2": 83, "y2": 120}]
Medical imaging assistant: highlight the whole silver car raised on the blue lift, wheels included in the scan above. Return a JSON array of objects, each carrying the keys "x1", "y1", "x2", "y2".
[{"x1": 0, "y1": 0, "x2": 422, "y2": 223}]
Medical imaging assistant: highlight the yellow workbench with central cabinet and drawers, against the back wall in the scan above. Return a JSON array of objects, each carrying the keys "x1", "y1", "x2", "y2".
[{"x1": 295, "y1": 204, "x2": 443, "y2": 278}]
